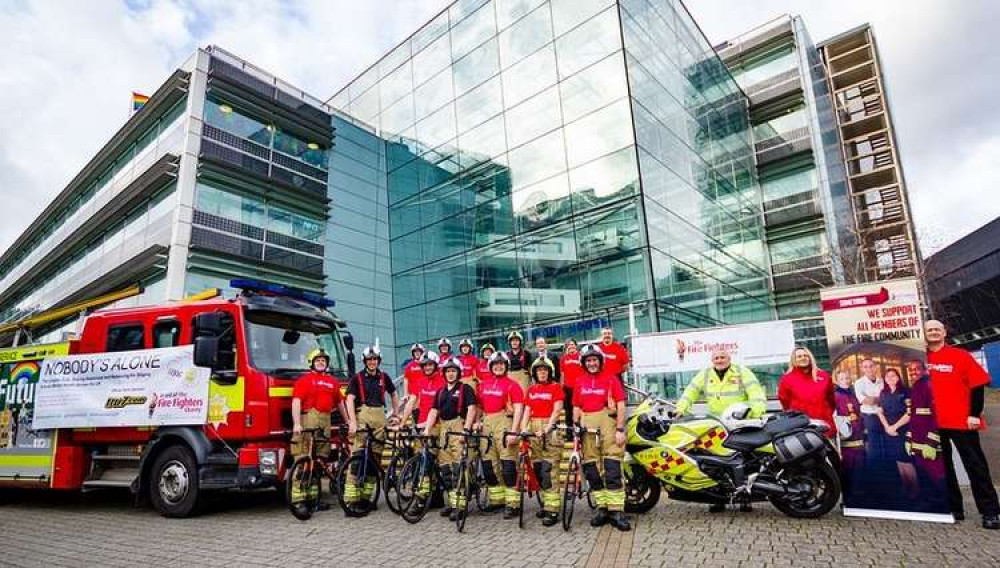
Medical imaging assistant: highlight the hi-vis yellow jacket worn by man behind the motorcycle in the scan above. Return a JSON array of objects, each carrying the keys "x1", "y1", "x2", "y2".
[{"x1": 677, "y1": 363, "x2": 767, "y2": 418}]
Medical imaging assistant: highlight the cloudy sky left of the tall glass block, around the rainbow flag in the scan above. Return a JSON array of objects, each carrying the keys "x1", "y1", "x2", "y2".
[{"x1": 0, "y1": 0, "x2": 446, "y2": 255}]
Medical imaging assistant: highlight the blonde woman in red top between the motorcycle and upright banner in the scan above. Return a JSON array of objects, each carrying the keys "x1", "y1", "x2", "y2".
[{"x1": 778, "y1": 347, "x2": 837, "y2": 438}]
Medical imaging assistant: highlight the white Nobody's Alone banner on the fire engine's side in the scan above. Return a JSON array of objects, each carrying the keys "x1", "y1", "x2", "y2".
[{"x1": 33, "y1": 345, "x2": 210, "y2": 430}]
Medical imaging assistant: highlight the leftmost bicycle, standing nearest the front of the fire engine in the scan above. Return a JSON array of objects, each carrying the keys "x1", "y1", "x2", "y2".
[{"x1": 285, "y1": 426, "x2": 350, "y2": 521}]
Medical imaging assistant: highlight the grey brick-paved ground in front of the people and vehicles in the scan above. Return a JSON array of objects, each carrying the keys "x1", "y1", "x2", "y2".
[{"x1": 0, "y1": 484, "x2": 1000, "y2": 568}]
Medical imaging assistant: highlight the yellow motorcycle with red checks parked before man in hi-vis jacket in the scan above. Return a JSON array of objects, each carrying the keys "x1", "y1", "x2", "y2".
[{"x1": 624, "y1": 389, "x2": 840, "y2": 518}]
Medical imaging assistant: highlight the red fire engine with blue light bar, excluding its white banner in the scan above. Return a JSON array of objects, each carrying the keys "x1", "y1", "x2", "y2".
[{"x1": 0, "y1": 280, "x2": 354, "y2": 517}]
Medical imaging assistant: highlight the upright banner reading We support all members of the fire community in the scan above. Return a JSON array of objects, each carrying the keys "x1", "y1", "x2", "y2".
[{"x1": 820, "y1": 279, "x2": 953, "y2": 522}]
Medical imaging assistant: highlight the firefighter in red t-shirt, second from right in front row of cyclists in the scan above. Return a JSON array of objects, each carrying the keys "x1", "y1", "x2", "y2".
[{"x1": 521, "y1": 357, "x2": 563, "y2": 527}]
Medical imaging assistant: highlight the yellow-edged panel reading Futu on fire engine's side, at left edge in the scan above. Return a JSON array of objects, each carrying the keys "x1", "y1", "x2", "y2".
[{"x1": 0, "y1": 343, "x2": 69, "y2": 486}]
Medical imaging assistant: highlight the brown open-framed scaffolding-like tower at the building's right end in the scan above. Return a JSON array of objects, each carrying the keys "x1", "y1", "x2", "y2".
[{"x1": 817, "y1": 25, "x2": 920, "y2": 282}]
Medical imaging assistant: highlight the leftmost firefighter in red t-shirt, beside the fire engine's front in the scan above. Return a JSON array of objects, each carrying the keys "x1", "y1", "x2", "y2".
[{"x1": 292, "y1": 349, "x2": 347, "y2": 457}]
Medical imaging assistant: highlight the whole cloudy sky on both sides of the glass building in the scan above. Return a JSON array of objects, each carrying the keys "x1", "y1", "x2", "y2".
[{"x1": 0, "y1": 0, "x2": 1000, "y2": 255}]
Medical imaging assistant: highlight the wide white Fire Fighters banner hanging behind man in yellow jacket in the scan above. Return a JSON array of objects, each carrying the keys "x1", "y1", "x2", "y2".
[{"x1": 632, "y1": 320, "x2": 795, "y2": 375}]
